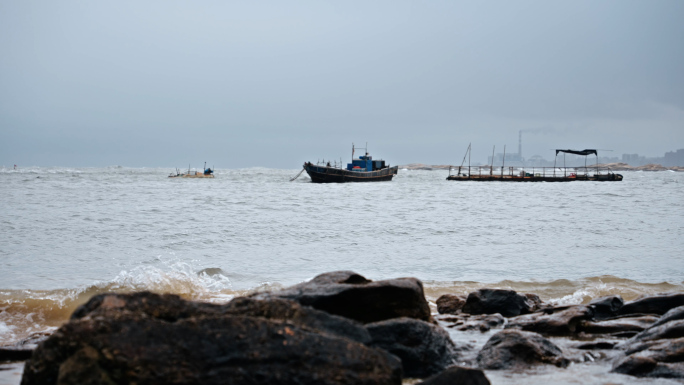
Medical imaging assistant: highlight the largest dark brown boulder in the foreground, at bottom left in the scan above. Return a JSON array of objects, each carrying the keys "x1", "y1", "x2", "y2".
[{"x1": 22, "y1": 306, "x2": 401, "y2": 385}]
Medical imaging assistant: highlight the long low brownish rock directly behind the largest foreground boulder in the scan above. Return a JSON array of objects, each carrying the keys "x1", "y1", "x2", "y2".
[{"x1": 71, "y1": 292, "x2": 370, "y2": 344}]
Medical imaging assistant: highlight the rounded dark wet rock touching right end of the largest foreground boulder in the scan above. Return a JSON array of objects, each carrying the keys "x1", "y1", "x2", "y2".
[{"x1": 366, "y1": 317, "x2": 456, "y2": 378}]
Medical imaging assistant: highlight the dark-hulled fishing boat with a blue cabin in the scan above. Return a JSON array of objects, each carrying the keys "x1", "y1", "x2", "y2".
[{"x1": 290, "y1": 144, "x2": 399, "y2": 183}]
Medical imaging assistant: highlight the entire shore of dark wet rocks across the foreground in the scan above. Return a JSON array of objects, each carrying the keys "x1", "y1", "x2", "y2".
[{"x1": 0, "y1": 271, "x2": 684, "y2": 385}]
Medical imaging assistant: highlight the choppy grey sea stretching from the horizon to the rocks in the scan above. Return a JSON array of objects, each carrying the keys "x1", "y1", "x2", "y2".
[{"x1": 0, "y1": 166, "x2": 684, "y2": 384}]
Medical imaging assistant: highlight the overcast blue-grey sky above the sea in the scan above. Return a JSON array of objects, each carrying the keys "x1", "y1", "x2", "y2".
[{"x1": 0, "y1": 0, "x2": 684, "y2": 169}]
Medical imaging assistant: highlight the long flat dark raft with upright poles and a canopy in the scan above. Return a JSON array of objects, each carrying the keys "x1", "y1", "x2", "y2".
[{"x1": 447, "y1": 145, "x2": 623, "y2": 182}]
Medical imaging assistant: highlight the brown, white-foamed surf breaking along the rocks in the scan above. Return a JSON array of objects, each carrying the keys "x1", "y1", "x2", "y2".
[{"x1": 0, "y1": 268, "x2": 684, "y2": 346}]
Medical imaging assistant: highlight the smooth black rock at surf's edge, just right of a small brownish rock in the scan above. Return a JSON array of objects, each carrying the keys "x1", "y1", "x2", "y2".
[{"x1": 462, "y1": 289, "x2": 541, "y2": 317}]
